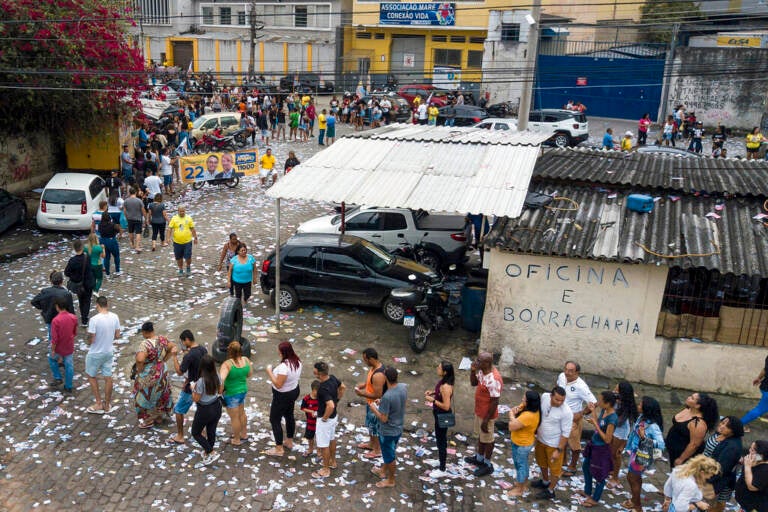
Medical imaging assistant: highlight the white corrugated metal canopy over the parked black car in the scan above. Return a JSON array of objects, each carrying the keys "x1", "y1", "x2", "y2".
[{"x1": 267, "y1": 124, "x2": 548, "y2": 217}]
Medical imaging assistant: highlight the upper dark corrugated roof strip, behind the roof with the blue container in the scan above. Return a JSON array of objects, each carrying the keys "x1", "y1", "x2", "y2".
[{"x1": 534, "y1": 149, "x2": 768, "y2": 197}]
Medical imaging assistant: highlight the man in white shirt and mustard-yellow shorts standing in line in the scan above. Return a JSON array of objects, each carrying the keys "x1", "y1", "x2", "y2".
[{"x1": 531, "y1": 386, "x2": 573, "y2": 500}]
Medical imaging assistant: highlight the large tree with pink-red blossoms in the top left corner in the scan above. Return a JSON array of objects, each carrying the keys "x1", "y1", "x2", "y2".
[{"x1": 0, "y1": 0, "x2": 146, "y2": 133}]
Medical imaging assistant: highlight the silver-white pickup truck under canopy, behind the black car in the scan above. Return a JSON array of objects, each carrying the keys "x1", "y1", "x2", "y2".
[{"x1": 298, "y1": 206, "x2": 467, "y2": 270}]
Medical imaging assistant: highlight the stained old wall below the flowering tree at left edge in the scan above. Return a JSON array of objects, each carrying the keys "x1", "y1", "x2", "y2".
[{"x1": 0, "y1": 131, "x2": 58, "y2": 193}]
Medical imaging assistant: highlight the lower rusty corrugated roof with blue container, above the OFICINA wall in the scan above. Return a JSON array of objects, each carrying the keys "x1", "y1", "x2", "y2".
[{"x1": 488, "y1": 182, "x2": 768, "y2": 276}]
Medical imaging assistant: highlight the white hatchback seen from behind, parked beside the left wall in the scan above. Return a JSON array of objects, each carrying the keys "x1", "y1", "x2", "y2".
[{"x1": 37, "y1": 172, "x2": 107, "y2": 231}]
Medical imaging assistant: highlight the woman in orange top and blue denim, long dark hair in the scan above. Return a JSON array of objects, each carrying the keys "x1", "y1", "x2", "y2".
[{"x1": 507, "y1": 389, "x2": 541, "y2": 497}]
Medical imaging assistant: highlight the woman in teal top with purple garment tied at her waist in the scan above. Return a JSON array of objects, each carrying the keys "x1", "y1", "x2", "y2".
[{"x1": 581, "y1": 391, "x2": 619, "y2": 508}]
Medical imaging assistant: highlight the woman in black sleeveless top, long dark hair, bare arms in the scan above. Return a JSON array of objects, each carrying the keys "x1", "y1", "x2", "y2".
[{"x1": 664, "y1": 393, "x2": 720, "y2": 468}]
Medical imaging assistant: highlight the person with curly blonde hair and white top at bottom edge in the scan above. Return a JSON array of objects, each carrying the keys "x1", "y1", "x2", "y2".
[{"x1": 661, "y1": 455, "x2": 720, "y2": 512}]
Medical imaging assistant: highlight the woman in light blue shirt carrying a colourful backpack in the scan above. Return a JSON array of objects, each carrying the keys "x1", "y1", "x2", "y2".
[{"x1": 621, "y1": 396, "x2": 664, "y2": 512}]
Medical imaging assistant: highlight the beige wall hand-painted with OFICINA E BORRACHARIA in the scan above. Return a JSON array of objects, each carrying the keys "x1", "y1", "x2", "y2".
[{"x1": 481, "y1": 249, "x2": 765, "y2": 395}]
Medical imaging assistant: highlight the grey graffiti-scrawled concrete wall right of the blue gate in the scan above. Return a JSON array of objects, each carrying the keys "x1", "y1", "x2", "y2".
[{"x1": 669, "y1": 48, "x2": 768, "y2": 130}]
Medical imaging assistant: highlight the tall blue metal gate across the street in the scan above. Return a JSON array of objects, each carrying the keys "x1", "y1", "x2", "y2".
[{"x1": 534, "y1": 42, "x2": 666, "y2": 119}]
